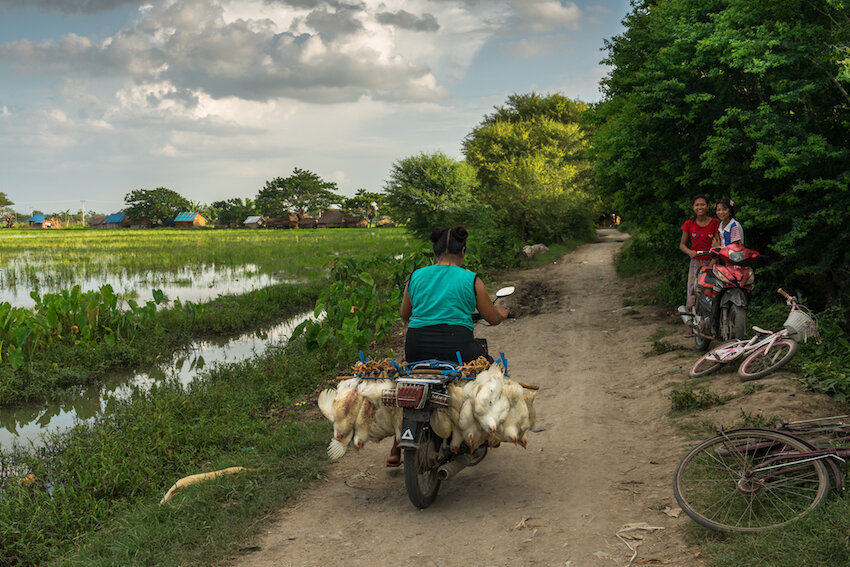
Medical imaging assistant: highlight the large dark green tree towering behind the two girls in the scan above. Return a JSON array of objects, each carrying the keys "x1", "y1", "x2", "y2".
[{"x1": 593, "y1": 0, "x2": 850, "y2": 306}]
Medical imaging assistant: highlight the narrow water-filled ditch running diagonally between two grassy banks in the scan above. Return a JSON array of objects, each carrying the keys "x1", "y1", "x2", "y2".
[{"x1": 0, "y1": 312, "x2": 312, "y2": 448}]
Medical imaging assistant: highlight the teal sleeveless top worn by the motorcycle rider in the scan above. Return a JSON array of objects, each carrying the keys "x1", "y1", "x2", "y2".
[{"x1": 407, "y1": 264, "x2": 476, "y2": 330}]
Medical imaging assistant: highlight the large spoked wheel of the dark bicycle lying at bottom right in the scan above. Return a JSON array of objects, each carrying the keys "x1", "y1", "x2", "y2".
[{"x1": 673, "y1": 429, "x2": 829, "y2": 533}]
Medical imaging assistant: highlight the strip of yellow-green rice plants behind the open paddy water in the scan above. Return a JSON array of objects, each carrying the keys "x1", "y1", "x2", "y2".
[{"x1": 0, "y1": 228, "x2": 420, "y2": 289}]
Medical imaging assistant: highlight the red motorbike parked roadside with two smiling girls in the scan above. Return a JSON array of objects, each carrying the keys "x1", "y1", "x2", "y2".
[{"x1": 679, "y1": 243, "x2": 759, "y2": 351}]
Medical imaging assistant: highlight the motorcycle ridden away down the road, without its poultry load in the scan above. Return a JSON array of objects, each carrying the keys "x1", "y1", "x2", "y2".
[{"x1": 381, "y1": 287, "x2": 515, "y2": 509}]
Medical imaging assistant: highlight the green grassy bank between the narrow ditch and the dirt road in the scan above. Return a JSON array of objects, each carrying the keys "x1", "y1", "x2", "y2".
[{"x1": 0, "y1": 332, "x2": 356, "y2": 567}]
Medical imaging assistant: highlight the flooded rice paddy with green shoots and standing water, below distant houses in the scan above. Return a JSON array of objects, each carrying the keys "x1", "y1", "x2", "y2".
[{"x1": 0, "y1": 229, "x2": 420, "y2": 307}]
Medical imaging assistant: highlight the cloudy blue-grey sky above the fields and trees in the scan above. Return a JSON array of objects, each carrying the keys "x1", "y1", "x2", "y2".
[{"x1": 0, "y1": 0, "x2": 628, "y2": 213}]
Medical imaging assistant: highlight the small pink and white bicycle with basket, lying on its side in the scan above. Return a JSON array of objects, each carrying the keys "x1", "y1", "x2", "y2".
[{"x1": 688, "y1": 289, "x2": 818, "y2": 382}]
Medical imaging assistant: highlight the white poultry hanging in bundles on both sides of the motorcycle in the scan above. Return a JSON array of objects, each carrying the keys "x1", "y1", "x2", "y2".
[{"x1": 319, "y1": 363, "x2": 537, "y2": 460}]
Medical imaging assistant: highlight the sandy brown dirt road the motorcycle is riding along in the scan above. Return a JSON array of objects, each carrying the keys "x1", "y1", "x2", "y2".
[{"x1": 224, "y1": 230, "x2": 840, "y2": 567}]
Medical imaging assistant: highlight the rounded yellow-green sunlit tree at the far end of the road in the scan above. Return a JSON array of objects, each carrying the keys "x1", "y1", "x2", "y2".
[{"x1": 463, "y1": 93, "x2": 596, "y2": 241}]
